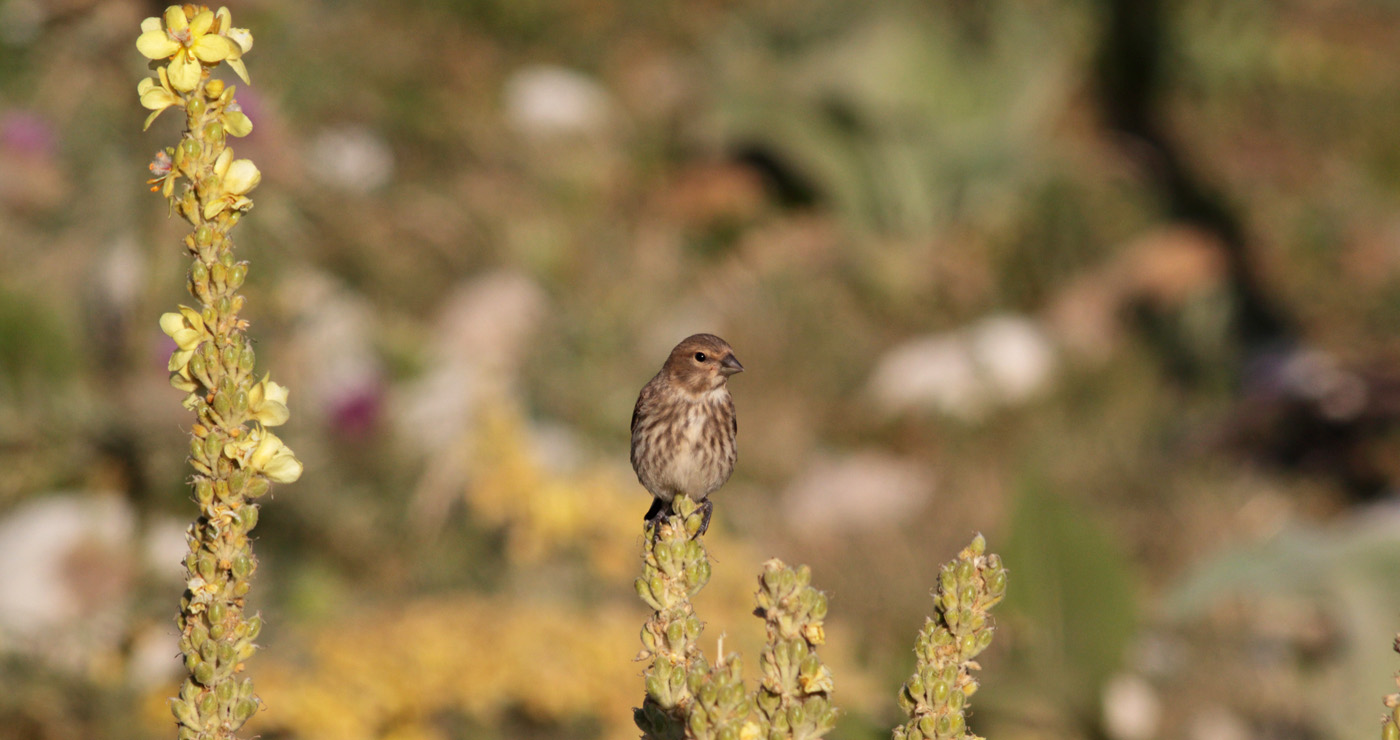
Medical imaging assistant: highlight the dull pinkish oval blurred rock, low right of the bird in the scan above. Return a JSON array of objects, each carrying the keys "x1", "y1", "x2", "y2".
[{"x1": 783, "y1": 452, "x2": 934, "y2": 534}]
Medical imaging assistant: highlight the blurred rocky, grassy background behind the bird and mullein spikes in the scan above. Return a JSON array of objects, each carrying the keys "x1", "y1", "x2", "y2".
[{"x1": 0, "y1": 0, "x2": 1400, "y2": 740}]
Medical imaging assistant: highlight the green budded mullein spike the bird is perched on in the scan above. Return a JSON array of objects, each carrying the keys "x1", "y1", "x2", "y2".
[{"x1": 633, "y1": 497, "x2": 716, "y2": 740}]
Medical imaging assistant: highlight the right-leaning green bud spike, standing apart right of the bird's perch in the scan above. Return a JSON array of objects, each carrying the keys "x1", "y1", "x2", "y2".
[{"x1": 893, "y1": 534, "x2": 1007, "y2": 740}]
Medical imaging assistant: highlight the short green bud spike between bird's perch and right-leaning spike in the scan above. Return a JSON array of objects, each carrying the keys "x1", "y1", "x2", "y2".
[{"x1": 755, "y1": 560, "x2": 839, "y2": 740}]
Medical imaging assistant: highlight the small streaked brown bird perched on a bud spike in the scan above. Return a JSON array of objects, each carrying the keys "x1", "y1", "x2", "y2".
[{"x1": 631, "y1": 334, "x2": 743, "y2": 534}]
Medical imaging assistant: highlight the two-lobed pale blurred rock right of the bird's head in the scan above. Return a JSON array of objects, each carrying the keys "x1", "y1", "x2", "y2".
[{"x1": 867, "y1": 316, "x2": 1056, "y2": 421}]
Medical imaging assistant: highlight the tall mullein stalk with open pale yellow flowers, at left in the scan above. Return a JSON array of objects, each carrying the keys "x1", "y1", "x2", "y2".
[{"x1": 136, "y1": 6, "x2": 301, "y2": 740}]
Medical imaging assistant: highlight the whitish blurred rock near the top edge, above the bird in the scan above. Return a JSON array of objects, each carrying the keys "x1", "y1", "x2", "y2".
[{"x1": 504, "y1": 64, "x2": 615, "y2": 140}]
